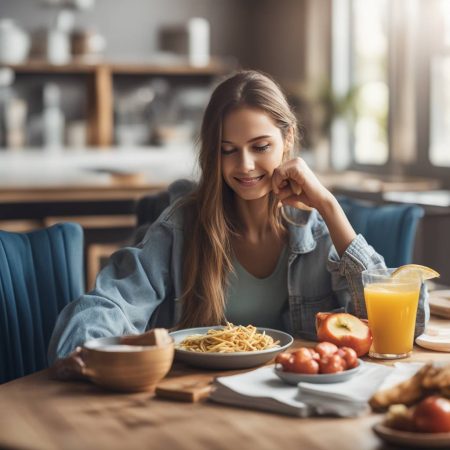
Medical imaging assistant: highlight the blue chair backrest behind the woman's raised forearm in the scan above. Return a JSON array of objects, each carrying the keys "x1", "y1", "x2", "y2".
[{"x1": 338, "y1": 197, "x2": 424, "y2": 267}]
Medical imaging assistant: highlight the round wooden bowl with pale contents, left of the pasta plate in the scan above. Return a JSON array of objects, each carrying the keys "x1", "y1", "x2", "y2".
[{"x1": 83, "y1": 337, "x2": 174, "y2": 392}]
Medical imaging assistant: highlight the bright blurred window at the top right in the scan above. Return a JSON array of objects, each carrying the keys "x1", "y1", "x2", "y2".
[{"x1": 332, "y1": 0, "x2": 450, "y2": 179}]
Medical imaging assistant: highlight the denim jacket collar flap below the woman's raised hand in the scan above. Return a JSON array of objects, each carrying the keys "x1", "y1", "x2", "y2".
[{"x1": 287, "y1": 208, "x2": 328, "y2": 253}]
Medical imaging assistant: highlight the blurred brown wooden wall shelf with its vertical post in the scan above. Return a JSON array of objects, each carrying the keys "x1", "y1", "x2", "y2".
[{"x1": 4, "y1": 59, "x2": 232, "y2": 148}]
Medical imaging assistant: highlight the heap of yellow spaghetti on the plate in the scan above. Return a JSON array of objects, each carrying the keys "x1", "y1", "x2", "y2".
[{"x1": 177, "y1": 322, "x2": 280, "y2": 353}]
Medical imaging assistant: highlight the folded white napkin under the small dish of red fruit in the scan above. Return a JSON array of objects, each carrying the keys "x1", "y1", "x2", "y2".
[{"x1": 210, "y1": 362, "x2": 422, "y2": 417}]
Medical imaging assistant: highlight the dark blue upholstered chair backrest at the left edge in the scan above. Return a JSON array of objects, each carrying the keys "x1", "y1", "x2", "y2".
[{"x1": 0, "y1": 223, "x2": 84, "y2": 383}]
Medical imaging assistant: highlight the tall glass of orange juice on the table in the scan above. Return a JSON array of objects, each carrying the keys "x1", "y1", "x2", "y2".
[{"x1": 362, "y1": 269, "x2": 421, "y2": 359}]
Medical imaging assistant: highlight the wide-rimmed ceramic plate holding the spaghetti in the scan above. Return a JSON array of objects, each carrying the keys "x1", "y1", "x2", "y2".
[{"x1": 170, "y1": 326, "x2": 294, "y2": 369}]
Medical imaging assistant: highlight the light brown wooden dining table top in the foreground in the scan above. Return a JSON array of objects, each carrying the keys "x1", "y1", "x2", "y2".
[{"x1": 0, "y1": 318, "x2": 450, "y2": 450}]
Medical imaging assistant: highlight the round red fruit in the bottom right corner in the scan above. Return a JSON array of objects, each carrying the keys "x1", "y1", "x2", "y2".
[{"x1": 413, "y1": 395, "x2": 450, "y2": 433}]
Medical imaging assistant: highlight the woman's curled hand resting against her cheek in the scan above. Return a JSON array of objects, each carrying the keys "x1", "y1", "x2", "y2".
[{"x1": 272, "y1": 158, "x2": 334, "y2": 214}]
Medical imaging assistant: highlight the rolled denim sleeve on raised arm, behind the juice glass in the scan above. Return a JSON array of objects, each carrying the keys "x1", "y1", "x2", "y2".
[{"x1": 327, "y1": 234, "x2": 429, "y2": 336}]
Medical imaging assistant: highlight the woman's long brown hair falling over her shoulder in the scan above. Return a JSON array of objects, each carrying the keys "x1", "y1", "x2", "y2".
[{"x1": 178, "y1": 70, "x2": 297, "y2": 328}]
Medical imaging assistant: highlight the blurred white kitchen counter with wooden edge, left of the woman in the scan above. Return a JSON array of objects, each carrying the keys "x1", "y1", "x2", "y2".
[{"x1": 0, "y1": 146, "x2": 196, "y2": 202}]
